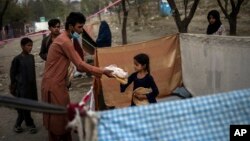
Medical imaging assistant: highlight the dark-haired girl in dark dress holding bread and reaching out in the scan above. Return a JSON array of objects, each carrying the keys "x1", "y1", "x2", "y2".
[{"x1": 120, "y1": 53, "x2": 159, "y2": 106}]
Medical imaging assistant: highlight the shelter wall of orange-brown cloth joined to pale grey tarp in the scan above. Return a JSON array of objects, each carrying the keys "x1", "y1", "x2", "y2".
[{"x1": 94, "y1": 34, "x2": 250, "y2": 110}]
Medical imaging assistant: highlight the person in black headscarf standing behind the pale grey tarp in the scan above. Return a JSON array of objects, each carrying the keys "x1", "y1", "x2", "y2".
[{"x1": 207, "y1": 10, "x2": 225, "y2": 35}]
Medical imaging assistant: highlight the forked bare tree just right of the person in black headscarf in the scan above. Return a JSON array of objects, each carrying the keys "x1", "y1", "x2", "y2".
[{"x1": 217, "y1": 0, "x2": 244, "y2": 35}]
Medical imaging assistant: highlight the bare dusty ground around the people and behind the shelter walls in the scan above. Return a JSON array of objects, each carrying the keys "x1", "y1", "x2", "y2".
[{"x1": 0, "y1": 6, "x2": 250, "y2": 141}]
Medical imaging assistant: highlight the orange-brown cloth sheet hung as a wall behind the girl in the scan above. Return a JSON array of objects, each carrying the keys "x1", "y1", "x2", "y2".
[{"x1": 94, "y1": 34, "x2": 182, "y2": 110}]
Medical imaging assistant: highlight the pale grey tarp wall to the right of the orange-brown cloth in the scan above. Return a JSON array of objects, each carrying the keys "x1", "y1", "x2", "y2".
[{"x1": 180, "y1": 34, "x2": 250, "y2": 96}]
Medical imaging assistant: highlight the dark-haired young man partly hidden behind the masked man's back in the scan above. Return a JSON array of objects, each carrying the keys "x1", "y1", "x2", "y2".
[{"x1": 39, "y1": 19, "x2": 61, "y2": 61}]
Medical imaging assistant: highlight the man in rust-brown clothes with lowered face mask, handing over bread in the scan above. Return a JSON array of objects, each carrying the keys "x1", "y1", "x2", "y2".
[{"x1": 41, "y1": 12, "x2": 112, "y2": 141}]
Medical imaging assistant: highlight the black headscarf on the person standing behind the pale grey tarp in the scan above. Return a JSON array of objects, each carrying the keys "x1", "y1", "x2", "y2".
[{"x1": 207, "y1": 10, "x2": 222, "y2": 35}]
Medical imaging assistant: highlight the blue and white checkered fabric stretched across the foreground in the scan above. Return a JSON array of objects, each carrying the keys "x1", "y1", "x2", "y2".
[{"x1": 98, "y1": 89, "x2": 250, "y2": 141}]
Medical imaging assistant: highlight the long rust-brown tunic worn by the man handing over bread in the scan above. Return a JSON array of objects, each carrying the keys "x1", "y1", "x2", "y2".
[{"x1": 41, "y1": 31, "x2": 103, "y2": 135}]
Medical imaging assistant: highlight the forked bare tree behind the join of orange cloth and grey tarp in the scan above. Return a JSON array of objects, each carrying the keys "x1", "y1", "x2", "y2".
[{"x1": 168, "y1": 0, "x2": 200, "y2": 33}]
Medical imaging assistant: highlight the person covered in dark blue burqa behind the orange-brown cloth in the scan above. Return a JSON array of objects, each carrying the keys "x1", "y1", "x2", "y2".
[{"x1": 96, "y1": 21, "x2": 112, "y2": 47}]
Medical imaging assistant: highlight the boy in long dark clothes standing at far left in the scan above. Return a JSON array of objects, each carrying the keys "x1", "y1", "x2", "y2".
[{"x1": 10, "y1": 38, "x2": 37, "y2": 134}]
